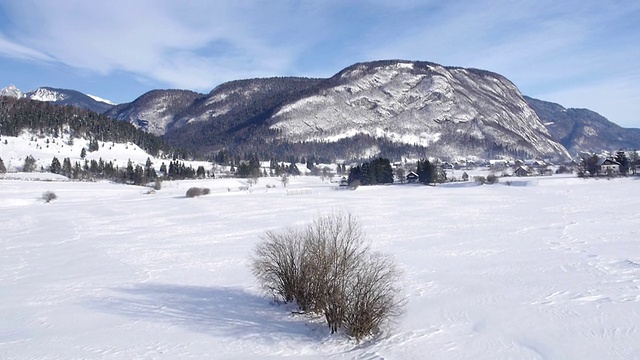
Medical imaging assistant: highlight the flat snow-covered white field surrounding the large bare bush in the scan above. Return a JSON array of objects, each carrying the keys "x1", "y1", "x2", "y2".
[{"x1": 0, "y1": 176, "x2": 640, "y2": 360}]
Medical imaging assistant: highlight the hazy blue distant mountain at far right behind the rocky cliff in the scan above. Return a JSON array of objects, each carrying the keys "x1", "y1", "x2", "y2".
[{"x1": 524, "y1": 96, "x2": 640, "y2": 155}]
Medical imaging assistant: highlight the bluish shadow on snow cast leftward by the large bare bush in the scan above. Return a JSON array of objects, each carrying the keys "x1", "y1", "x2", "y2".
[{"x1": 89, "y1": 284, "x2": 326, "y2": 342}]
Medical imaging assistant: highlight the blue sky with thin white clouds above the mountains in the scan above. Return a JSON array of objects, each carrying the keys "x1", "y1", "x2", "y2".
[{"x1": 0, "y1": 0, "x2": 640, "y2": 127}]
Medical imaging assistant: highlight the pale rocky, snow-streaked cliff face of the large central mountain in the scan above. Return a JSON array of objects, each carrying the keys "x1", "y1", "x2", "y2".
[{"x1": 269, "y1": 61, "x2": 568, "y2": 157}]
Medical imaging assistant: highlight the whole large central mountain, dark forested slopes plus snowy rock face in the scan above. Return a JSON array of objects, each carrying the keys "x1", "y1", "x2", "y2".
[{"x1": 108, "y1": 60, "x2": 569, "y2": 159}]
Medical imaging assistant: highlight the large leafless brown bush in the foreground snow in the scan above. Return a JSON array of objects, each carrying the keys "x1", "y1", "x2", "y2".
[{"x1": 252, "y1": 214, "x2": 402, "y2": 339}]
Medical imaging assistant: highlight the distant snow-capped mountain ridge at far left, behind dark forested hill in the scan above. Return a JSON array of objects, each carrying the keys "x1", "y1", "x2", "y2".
[{"x1": 0, "y1": 85, "x2": 114, "y2": 113}]
